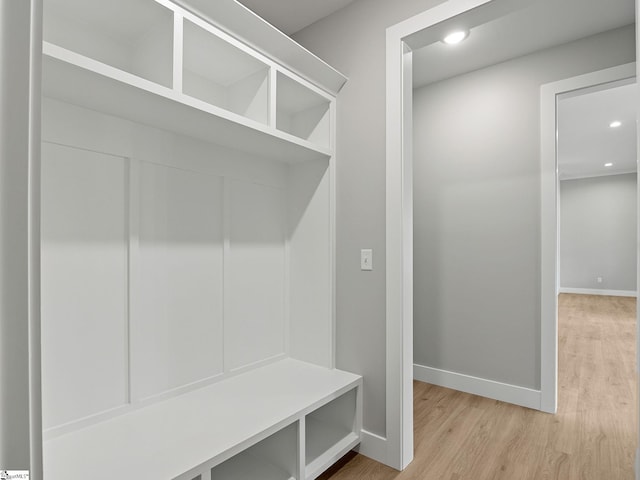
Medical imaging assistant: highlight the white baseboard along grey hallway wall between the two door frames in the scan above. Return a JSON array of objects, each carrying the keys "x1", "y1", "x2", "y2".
[{"x1": 413, "y1": 365, "x2": 541, "y2": 410}]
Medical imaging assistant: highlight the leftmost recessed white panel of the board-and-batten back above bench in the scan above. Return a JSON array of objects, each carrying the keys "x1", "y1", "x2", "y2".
[{"x1": 42, "y1": 143, "x2": 129, "y2": 428}]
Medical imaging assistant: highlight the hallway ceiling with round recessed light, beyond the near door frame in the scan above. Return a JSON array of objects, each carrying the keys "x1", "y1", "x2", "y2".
[{"x1": 414, "y1": 0, "x2": 635, "y2": 87}]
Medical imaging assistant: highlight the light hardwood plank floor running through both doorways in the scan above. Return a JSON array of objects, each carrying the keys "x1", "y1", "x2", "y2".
[{"x1": 320, "y1": 294, "x2": 638, "y2": 480}]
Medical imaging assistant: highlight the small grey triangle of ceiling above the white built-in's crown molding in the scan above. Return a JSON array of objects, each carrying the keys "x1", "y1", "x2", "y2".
[{"x1": 238, "y1": 0, "x2": 356, "y2": 35}]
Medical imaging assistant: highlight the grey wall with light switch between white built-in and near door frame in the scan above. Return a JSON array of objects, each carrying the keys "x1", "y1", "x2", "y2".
[{"x1": 294, "y1": 0, "x2": 442, "y2": 436}]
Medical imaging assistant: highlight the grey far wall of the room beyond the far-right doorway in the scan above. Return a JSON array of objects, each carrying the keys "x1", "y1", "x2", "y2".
[{"x1": 560, "y1": 173, "x2": 637, "y2": 291}]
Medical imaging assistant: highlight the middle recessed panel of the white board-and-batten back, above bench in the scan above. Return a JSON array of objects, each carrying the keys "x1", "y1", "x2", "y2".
[{"x1": 131, "y1": 162, "x2": 223, "y2": 399}]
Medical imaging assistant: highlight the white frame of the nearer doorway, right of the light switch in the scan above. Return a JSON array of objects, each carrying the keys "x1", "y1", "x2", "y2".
[{"x1": 386, "y1": 0, "x2": 527, "y2": 470}]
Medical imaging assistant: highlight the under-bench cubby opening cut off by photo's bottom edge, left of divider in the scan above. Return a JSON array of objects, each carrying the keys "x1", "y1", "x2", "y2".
[{"x1": 211, "y1": 422, "x2": 299, "y2": 480}]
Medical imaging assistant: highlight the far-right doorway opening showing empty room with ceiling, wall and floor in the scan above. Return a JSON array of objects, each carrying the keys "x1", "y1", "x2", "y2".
[{"x1": 556, "y1": 77, "x2": 638, "y2": 436}]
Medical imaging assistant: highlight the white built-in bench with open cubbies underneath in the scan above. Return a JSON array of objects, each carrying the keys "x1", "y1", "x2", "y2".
[{"x1": 44, "y1": 359, "x2": 362, "y2": 480}]
